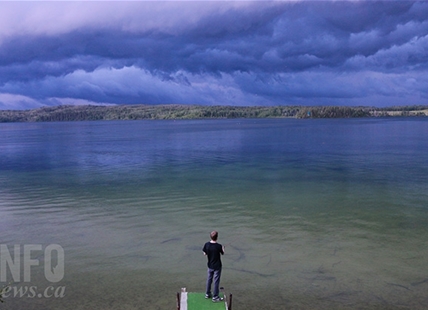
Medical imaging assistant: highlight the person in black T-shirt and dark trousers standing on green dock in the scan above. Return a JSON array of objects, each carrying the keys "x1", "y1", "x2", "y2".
[{"x1": 202, "y1": 230, "x2": 224, "y2": 302}]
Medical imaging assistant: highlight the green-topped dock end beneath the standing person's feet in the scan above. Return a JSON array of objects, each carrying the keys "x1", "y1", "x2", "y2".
[{"x1": 177, "y1": 288, "x2": 232, "y2": 310}]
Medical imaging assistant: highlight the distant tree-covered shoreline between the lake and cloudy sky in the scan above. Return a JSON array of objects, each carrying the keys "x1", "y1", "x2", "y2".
[{"x1": 0, "y1": 104, "x2": 428, "y2": 123}]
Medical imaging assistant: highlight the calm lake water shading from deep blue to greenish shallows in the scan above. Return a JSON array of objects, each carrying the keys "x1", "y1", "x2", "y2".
[{"x1": 0, "y1": 118, "x2": 428, "y2": 310}]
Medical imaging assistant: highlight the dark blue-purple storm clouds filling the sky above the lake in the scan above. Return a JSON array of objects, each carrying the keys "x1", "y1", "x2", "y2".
[{"x1": 0, "y1": 1, "x2": 428, "y2": 109}]
